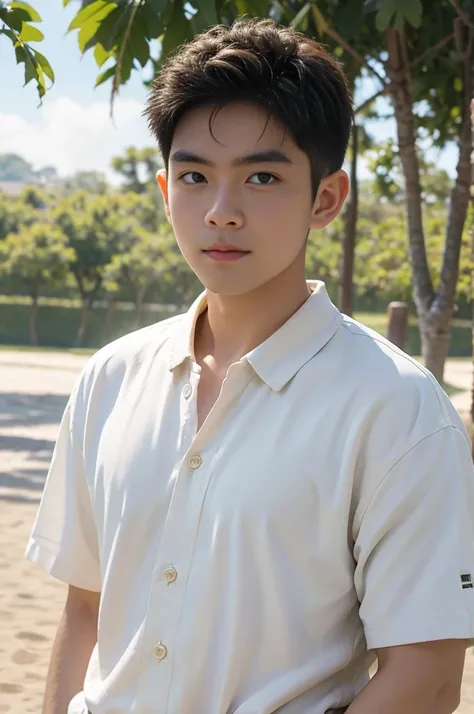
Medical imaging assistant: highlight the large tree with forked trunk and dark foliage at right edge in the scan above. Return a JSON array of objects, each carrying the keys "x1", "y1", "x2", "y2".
[{"x1": 290, "y1": 0, "x2": 474, "y2": 381}]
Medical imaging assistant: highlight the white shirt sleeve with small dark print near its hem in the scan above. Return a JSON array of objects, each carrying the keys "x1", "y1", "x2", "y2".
[{"x1": 354, "y1": 426, "x2": 474, "y2": 649}]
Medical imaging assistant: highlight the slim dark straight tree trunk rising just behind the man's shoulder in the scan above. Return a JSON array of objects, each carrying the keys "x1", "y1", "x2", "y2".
[{"x1": 339, "y1": 122, "x2": 359, "y2": 316}]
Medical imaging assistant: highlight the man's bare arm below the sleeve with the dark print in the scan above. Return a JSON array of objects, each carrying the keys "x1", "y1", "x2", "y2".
[{"x1": 347, "y1": 640, "x2": 466, "y2": 714}]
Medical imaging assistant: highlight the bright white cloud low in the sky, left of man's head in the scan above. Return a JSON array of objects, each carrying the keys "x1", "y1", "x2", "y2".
[{"x1": 0, "y1": 97, "x2": 153, "y2": 181}]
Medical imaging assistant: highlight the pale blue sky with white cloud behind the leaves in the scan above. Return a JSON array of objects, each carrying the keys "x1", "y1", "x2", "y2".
[{"x1": 0, "y1": 0, "x2": 456, "y2": 183}]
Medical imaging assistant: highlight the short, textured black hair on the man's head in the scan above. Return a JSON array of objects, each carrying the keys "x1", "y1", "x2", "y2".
[{"x1": 144, "y1": 19, "x2": 353, "y2": 195}]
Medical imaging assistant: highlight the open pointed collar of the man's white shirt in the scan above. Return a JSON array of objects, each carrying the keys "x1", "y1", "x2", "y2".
[{"x1": 169, "y1": 280, "x2": 343, "y2": 392}]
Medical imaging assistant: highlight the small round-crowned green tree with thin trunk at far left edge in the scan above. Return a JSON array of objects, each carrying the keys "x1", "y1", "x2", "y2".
[{"x1": 0, "y1": 222, "x2": 74, "y2": 345}]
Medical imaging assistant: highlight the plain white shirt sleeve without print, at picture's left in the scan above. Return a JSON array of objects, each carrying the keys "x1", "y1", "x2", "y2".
[{"x1": 25, "y1": 386, "x2": 101, "y2": 592}]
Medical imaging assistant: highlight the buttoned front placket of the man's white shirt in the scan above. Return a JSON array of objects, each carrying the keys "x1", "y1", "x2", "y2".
[{"x1": 134, "y1": 362, "x2": 252, "y2": 714}]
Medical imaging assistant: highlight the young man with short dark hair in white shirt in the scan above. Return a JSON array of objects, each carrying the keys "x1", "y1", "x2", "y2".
[{"x1": 27, "y1": 16, "x2": 474, "y2": 714}]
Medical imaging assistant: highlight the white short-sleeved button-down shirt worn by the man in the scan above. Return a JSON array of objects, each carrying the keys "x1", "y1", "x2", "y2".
[{"x1": 27, "y1": 283, "x2": 474, "y2": 714}]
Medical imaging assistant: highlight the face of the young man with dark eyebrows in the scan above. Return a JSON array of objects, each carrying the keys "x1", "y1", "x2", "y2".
[{"x1": 158, "y1": 103, "x2": 346, "y2": 295}]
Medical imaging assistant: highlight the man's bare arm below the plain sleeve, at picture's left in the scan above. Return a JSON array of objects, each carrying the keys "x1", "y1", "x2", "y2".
[{"x1": 43, "y1": 586, "x2": 100, "y2": 714}]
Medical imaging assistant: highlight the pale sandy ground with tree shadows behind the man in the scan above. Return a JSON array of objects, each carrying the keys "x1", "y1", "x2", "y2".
[{"x1": 0, "y1": 351, "x2": 474, "y2": 714}]
